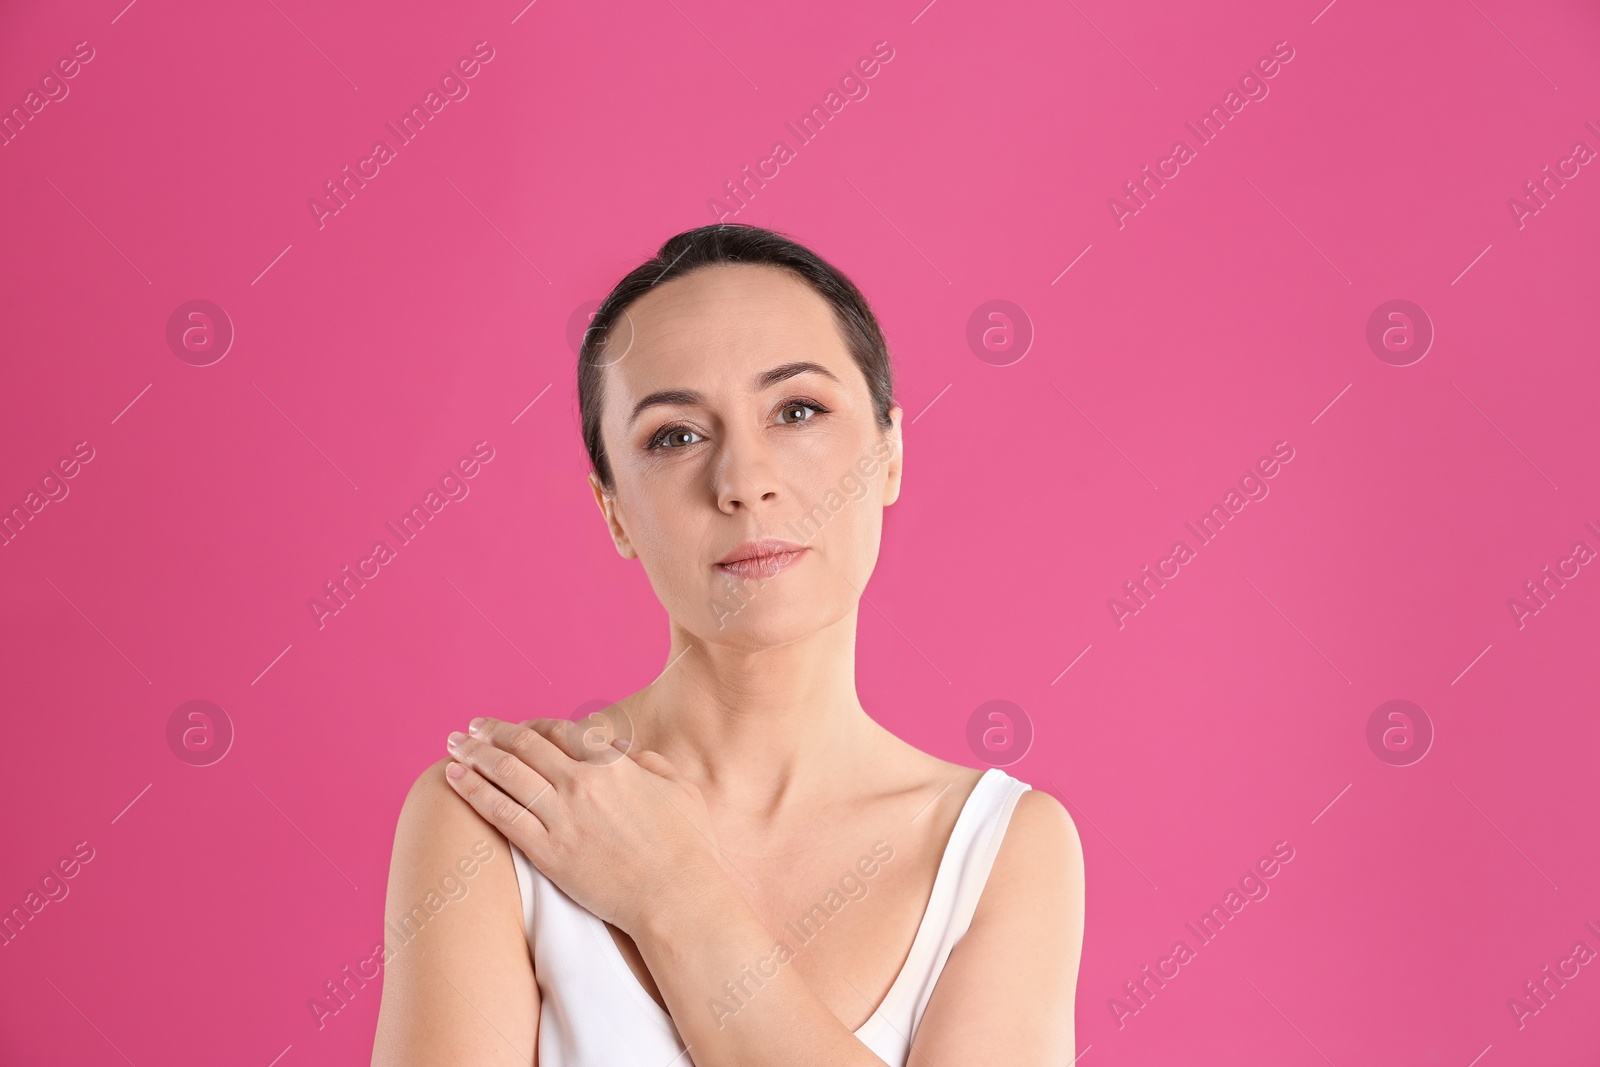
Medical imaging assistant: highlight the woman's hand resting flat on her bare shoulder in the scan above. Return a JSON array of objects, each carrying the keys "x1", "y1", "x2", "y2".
[{"x1": 446, "y1": 718, "x2": 726, "y2": 936}]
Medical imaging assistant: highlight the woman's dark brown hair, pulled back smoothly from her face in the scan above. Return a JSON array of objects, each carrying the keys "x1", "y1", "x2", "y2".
[{"x1": 578, "y1": 222, "x2": 894, "y2": 491}]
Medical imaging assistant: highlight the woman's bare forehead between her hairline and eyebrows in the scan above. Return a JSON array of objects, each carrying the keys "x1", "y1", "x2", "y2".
[{"x1": 606, "y1": 266, "x2": 853, "y2": 402}]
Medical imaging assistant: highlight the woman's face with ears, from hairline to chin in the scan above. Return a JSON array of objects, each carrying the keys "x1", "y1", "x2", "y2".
[{"x1": 590, "y1": 266, "x2": 901, "y2": 649}]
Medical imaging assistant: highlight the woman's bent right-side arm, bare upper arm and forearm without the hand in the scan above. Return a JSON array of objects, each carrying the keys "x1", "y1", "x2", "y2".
[{"x1": 630, "y1": 790, "x2": 1083, "y2": 1067}]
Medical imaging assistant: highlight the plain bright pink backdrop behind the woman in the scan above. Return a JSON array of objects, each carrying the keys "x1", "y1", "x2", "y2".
[{"x1": 0, "y1": 0, "x2": 1600, "y2": 1067}]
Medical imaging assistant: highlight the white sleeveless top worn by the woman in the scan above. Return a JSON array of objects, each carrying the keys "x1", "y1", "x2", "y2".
[{"x1": 510, "y1": 768, "x2": 1030, "y2": 1067}]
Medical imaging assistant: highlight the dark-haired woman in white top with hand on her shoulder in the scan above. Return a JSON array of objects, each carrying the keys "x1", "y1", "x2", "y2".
[{"x1": 373, "y1": 224, "x2": 1083, "y2": 1067}]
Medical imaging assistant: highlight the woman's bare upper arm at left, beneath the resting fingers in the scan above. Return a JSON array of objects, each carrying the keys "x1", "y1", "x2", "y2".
[{"x1": 373, "y1": 758, "x2": 539, "y2": 1067}]
